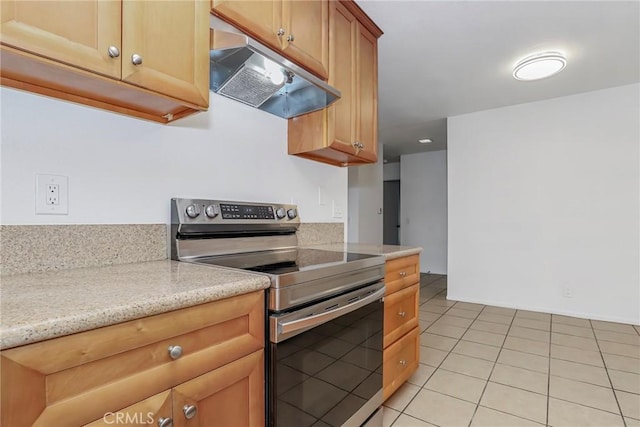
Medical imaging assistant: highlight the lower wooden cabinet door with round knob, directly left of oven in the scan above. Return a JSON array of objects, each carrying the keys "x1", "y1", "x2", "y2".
[{"x1": 173, "y1": 350, "x2": 265, "y2": 427}]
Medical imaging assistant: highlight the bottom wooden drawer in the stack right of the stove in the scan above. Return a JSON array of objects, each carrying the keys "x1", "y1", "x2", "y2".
[{"x1": 382, "y1": 327, "x2": 420, "y2": 400}]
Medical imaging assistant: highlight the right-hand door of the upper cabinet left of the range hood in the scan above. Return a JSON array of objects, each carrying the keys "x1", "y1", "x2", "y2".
[{"x1": 122, "y1": 0, "x2": 209, "y2": 107}]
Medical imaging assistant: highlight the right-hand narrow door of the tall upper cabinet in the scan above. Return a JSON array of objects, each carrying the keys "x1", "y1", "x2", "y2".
[{"x1": 356, "y1": 25, "x2": 378, "y2": 162}]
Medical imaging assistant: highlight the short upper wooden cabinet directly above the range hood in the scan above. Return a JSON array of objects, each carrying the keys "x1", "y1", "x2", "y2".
[{"x1": 212, "y1": 0, "x2": 329, "y2": 80}]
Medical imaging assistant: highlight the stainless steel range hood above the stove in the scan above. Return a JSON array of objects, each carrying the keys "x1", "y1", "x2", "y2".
[{"x1": 209, "y1": 16, "x2": 340, "y2": 119}]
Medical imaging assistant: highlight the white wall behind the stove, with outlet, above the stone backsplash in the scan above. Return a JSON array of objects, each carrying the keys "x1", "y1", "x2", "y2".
[{"x1": 0, "y1": 88, "x2": 347, "y2": 224}]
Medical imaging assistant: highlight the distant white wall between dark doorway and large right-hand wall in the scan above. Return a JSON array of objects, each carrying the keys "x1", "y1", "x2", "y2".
[{"x1": 400, "y1": 150, "x2": 447, "y2": 274}]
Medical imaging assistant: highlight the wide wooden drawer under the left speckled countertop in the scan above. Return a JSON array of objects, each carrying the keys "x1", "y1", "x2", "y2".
[{"x1": 0, "y1": 291, "x2": 264, "y2": 426}]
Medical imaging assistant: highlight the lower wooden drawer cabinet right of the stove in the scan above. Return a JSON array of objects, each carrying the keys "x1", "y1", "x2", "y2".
[{"x1": 382, "y1": 255, "x2": 420, "y2": 400}]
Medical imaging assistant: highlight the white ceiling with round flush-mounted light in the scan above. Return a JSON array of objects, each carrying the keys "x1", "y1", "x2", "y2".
[{"x1": 358, "y1": 0, "x2": 640, "y2": 161}]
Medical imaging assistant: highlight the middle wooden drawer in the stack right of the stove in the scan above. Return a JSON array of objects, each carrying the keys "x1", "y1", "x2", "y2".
[{"x1": 384, "y1": 284, "x2": 420, "y2": 348}]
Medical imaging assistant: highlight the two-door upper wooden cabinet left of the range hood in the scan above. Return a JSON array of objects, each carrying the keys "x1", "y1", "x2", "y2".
[{"x1": 0, "y1": 0, "x2": 209, "y2": 123}]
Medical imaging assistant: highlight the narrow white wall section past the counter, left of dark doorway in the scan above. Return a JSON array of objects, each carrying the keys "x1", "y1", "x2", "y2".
[{"x1": 347, "y1": 144, "x2": 383, "y2": 244}]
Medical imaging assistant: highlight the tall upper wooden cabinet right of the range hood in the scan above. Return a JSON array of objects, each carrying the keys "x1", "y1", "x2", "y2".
[{"x1": 288, "y1": 1, "x2": 382, "y2": 166}]
